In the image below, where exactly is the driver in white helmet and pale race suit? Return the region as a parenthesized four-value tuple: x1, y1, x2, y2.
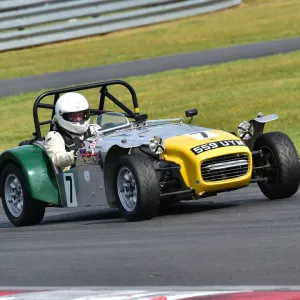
(45, 92, 100, 172)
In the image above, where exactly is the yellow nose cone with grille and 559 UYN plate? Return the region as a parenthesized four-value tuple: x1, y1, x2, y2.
(163, 130, 252, 196)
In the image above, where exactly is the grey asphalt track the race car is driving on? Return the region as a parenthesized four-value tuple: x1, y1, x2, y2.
(0, 184, 300, 286)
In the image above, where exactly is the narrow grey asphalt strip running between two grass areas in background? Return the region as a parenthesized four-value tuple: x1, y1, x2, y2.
(0, 37, 300, 97)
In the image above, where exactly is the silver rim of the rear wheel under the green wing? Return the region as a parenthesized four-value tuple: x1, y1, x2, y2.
(4, 174, 24, 218)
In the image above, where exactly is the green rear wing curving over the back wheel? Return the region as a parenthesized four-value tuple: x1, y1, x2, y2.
(0, 145, 61, 206)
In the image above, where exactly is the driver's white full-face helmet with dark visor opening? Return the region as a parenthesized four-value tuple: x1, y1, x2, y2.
(55, 92, 90, 134)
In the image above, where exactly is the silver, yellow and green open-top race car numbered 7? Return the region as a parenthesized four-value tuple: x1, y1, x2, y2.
(0, 80, 300, 226)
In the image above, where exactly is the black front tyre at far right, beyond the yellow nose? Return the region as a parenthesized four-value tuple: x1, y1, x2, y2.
(254, 132, 300, 199)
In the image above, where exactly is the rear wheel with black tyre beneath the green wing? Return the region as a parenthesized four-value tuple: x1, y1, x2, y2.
(0, 164, 45, 227)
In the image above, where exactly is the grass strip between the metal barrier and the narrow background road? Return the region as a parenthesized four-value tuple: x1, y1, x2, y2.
(0, 0, 300, 79)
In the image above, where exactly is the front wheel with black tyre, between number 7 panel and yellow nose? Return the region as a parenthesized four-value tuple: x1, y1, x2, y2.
(114, 154, 160, 221)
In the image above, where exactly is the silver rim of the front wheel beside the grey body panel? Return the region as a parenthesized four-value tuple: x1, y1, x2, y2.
(117, 167, 137, 211)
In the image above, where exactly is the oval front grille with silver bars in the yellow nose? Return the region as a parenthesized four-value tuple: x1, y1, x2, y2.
(201, 154, 249, 181)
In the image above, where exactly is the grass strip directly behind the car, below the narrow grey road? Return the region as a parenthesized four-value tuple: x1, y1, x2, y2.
(0, 51, 300, 153)
